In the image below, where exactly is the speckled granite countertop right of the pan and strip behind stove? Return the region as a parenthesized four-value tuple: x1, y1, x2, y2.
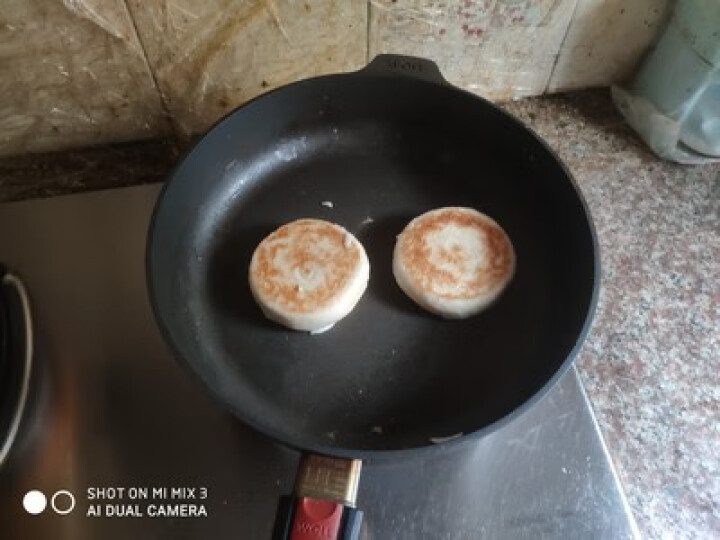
(0, 91, 720, 538)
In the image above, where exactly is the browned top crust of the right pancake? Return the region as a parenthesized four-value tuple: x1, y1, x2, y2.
(399, 208, 515, 300)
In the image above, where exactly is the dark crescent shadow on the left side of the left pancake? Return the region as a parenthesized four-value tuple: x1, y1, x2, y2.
(207, 224, 279, 330)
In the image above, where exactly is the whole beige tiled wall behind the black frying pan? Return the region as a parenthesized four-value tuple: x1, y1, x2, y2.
(0, 0, 670, 155)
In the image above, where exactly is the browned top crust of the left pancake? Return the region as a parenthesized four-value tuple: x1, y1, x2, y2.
(250, 219, 362, 313)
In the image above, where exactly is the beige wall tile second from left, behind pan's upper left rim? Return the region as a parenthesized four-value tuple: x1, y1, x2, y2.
(128, 0, 367, 134)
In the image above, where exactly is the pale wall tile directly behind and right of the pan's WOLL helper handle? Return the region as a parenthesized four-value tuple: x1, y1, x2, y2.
(369, 0, 577, 100)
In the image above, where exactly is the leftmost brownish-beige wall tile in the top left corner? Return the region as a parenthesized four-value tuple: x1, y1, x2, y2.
(0, 0, 170, 155)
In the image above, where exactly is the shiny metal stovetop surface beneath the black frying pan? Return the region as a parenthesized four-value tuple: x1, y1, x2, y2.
(0, 185, 637, 540)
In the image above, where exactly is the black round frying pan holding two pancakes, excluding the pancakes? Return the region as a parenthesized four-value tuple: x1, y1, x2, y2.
(147, 56, 599, 536)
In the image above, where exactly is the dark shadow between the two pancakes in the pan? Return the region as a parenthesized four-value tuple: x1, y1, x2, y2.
(357, 215, 435, 319)
